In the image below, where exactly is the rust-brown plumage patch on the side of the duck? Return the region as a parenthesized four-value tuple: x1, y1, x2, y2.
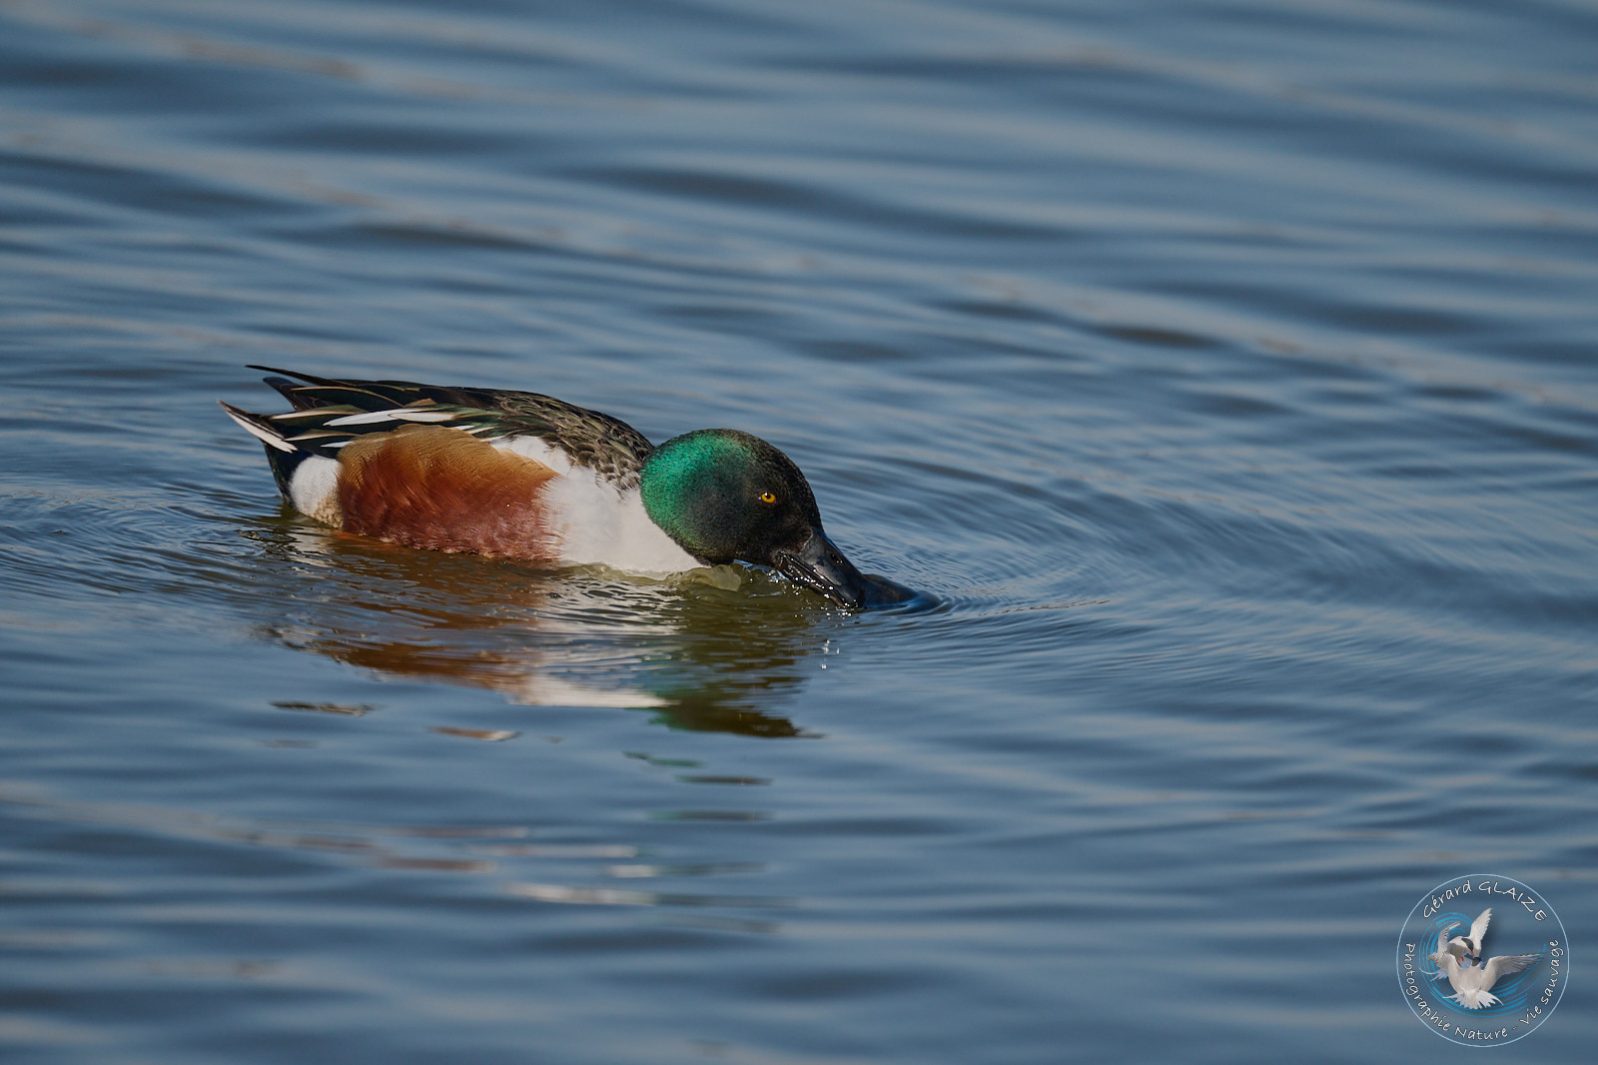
(339, 425, 559, 561)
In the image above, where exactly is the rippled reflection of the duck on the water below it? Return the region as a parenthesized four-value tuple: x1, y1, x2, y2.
(249, 518, 850, 737)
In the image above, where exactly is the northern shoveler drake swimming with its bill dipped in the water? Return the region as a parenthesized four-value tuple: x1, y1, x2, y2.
(222, 366, 912, 608)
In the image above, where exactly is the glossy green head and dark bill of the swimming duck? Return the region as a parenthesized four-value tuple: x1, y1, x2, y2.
(639, 429, 876, 608)
